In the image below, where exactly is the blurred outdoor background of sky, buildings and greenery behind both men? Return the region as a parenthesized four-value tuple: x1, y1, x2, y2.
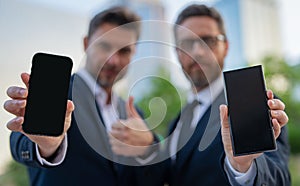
(0, 0, 300, 185)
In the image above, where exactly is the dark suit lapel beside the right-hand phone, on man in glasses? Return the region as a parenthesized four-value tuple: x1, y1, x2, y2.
(176, 91, 225, 170)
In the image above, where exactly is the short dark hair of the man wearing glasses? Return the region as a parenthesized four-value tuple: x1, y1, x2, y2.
(174, 4, 226, 39)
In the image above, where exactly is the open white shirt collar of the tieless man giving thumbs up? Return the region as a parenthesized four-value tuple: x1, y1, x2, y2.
(77, 68, 118, 107)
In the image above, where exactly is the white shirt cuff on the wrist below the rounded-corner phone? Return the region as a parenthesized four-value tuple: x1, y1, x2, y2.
(35, 134, 68, 166)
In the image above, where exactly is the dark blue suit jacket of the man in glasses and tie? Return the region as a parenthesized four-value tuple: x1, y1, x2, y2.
(137, 93, 290, 186)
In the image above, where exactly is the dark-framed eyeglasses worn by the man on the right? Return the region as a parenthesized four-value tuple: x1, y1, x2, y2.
(178, 34, 225, 52)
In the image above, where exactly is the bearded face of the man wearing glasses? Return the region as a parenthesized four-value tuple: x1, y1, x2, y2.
(175, 16, 228, 91)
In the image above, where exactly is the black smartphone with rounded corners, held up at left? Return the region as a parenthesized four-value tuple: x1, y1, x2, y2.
(23, 53, 73, 136)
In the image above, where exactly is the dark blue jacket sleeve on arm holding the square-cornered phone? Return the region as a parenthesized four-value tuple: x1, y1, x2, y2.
(255, 126, 291, 186)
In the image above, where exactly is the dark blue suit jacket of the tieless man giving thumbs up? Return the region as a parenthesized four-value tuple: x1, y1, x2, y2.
(10, 75, 134, 186)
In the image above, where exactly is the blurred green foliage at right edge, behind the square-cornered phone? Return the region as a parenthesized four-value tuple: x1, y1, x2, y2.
(262, 56, 300, 153)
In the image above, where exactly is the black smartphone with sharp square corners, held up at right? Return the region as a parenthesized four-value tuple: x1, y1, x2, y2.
(223, 65, 276, 156)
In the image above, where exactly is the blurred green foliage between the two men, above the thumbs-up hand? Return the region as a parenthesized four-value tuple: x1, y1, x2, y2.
(137, 67, 186, 137)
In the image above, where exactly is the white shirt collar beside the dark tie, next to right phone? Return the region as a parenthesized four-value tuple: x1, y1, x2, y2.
(187, 74, 224, 105)
